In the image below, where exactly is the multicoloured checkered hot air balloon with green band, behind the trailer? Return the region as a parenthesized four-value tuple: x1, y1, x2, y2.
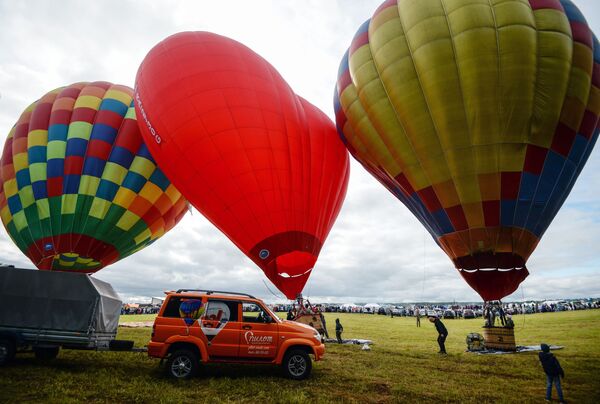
(0, 82, 187, 273)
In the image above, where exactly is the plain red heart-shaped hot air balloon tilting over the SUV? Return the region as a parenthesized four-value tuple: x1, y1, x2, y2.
(135, 32, 349, 299)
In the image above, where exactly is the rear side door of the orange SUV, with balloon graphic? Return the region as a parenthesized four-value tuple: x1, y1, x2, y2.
(198, 298, 240, 360)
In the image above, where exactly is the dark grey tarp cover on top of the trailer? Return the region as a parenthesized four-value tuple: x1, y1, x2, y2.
(0, 267, 122, 333)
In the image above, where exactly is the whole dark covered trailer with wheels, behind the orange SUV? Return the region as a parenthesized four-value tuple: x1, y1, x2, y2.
(0, 266, 133, 365)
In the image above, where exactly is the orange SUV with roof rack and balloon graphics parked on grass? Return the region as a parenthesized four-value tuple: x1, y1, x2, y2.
(148, 289, 325, 380)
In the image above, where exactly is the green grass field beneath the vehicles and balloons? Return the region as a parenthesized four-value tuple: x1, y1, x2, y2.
(0, 310, 600, 403)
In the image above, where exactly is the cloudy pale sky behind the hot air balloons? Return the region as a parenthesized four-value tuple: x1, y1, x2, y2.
(0, 0, 600, 302)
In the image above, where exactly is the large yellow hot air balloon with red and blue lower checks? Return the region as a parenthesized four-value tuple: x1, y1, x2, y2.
(334, 0, 600, 300)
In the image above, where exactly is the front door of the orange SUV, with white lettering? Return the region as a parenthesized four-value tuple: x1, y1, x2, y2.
(239, 303, 279, 360)
